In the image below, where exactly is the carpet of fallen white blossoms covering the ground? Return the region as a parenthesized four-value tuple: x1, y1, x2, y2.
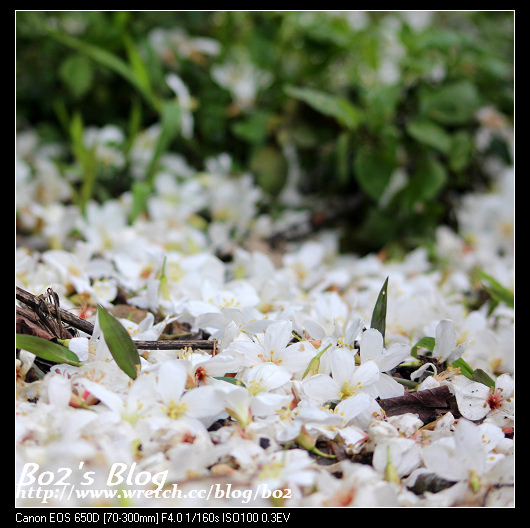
(16, 128, 514, 507)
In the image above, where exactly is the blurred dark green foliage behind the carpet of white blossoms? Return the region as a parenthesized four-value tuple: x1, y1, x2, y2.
(16, 11, 514, 252)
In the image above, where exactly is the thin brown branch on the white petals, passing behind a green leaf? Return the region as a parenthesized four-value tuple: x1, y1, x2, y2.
(16, 286, 217, 353)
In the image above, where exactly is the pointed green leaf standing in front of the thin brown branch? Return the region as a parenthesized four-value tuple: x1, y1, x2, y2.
(97, 304, 140, 379)
